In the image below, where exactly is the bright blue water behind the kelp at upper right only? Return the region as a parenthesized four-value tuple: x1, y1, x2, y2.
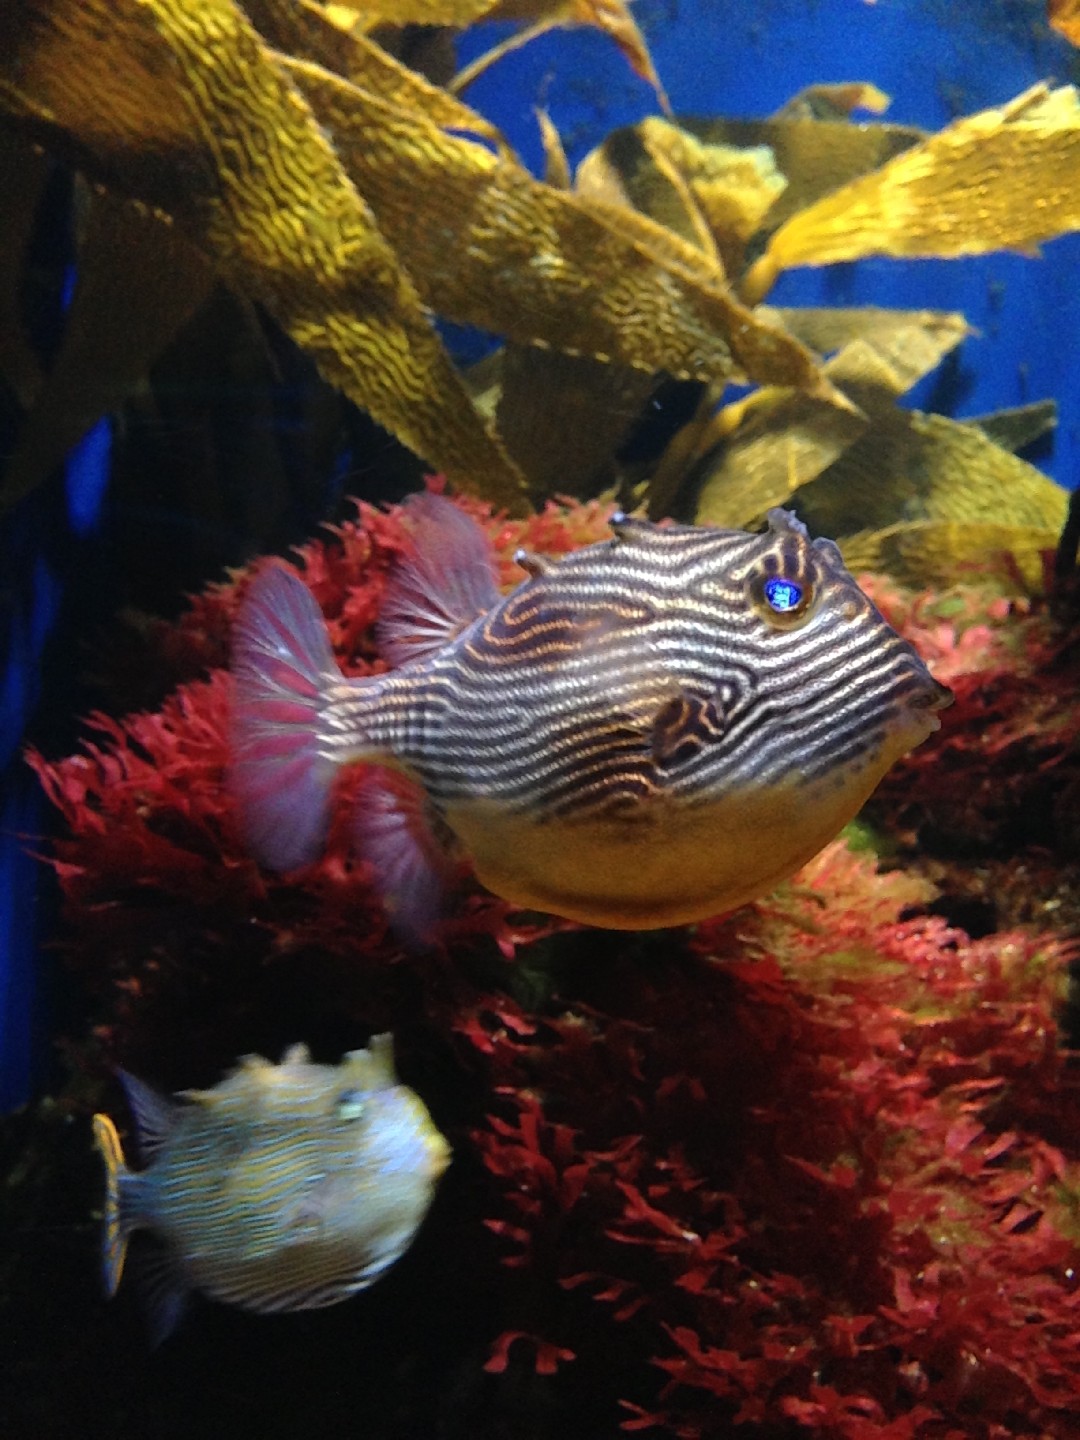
(459, 0, 1080, 463)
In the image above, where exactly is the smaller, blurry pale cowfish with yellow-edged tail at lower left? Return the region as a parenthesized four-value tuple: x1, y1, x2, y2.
(94, 1035, 449, 1339)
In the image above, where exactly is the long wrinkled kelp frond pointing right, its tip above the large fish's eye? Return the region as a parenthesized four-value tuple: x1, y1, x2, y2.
(284, 60, 829, 393)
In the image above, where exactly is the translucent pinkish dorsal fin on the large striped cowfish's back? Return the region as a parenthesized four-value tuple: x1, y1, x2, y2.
(376, 492, 500, 665)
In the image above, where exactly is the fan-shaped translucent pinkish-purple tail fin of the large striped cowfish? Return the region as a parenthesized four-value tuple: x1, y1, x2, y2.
(228, 562, 352, 871)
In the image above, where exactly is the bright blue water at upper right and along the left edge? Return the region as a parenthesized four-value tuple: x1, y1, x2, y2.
(0, 0, 1080, 1109)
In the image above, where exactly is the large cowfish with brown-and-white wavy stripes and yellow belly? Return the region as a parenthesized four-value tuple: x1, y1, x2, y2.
(230, 495, 952, 936)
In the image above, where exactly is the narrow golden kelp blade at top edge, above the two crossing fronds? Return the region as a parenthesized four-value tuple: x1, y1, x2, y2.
(243, 0, 505, 148)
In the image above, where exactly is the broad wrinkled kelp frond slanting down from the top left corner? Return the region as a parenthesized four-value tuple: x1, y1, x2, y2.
(0, 0, 523, 507)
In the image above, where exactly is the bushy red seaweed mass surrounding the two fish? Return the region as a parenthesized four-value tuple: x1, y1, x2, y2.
(23, 503, 1080, 1440)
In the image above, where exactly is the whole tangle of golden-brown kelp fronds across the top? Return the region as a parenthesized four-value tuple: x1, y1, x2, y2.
(0, 0, 1080, 555)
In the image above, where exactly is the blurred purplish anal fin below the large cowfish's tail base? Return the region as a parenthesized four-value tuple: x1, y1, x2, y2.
(354, 769, 454, 946)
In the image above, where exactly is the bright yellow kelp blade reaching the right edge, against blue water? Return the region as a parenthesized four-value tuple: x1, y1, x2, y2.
(744, 85, 1080, 300)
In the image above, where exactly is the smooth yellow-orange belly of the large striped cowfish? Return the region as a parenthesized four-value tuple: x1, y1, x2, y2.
(446, 756, 894, 930)
